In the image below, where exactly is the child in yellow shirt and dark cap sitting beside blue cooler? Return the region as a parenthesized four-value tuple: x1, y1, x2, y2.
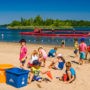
(28, 60, 46, 84)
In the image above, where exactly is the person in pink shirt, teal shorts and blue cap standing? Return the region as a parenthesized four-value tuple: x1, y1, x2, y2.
(79, 38, 87, 64)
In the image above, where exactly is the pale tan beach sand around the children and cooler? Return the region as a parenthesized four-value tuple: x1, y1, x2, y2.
(0, 42, 90, 90)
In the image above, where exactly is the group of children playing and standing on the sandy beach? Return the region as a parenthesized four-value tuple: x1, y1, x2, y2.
(19, 38, 90, 83)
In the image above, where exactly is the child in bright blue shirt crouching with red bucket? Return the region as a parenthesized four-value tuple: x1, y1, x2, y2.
(59, 62, 76, 83)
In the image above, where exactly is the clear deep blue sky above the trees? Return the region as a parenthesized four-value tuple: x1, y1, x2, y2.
(0, 0, 90, 24)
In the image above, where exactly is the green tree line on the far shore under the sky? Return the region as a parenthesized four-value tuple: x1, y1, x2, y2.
(9, 15, 90, 27)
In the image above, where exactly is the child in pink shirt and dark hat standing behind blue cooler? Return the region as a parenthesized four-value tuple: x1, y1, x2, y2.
(19, 39, 27, 68)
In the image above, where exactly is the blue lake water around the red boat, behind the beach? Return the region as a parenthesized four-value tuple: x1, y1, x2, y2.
(0, 28, 90, 46)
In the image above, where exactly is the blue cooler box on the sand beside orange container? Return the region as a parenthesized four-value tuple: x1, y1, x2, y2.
(6, 68, 29, 88)
